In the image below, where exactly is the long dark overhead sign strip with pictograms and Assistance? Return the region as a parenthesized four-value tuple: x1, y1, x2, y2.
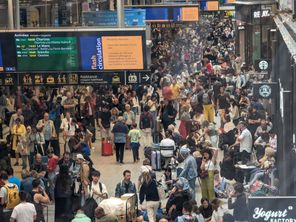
(0, 70, 151, 86)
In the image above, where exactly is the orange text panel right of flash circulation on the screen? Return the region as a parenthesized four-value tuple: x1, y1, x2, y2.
(102, 36, 144, 70)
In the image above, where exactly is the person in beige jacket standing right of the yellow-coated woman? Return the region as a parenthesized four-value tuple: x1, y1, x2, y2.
(36, 113, 57, 153)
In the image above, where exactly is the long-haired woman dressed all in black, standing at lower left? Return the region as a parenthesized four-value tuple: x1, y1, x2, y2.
(54, 165, 72, 220)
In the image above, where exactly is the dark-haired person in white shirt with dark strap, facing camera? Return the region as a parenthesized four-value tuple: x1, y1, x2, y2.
(88, 171, 108, 205)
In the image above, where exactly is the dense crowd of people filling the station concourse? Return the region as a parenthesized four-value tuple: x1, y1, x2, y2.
(0, 17, 278, 222)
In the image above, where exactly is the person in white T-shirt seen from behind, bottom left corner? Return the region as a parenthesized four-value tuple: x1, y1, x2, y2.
(10, 191, 37, 222)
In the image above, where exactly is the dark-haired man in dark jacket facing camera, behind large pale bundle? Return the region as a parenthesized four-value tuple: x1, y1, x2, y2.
(115, 170, 137, 198)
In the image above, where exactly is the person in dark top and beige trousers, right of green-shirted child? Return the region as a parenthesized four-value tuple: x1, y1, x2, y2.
(140, 106, 154, 147)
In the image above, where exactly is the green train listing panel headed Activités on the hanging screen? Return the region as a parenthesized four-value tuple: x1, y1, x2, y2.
(15, 34, 79, 71)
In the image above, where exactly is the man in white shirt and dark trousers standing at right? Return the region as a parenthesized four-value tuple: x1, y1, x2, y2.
(231, 121, 253, 163)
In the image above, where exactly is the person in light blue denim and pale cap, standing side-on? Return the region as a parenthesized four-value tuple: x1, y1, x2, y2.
(179, 146, 197, 200)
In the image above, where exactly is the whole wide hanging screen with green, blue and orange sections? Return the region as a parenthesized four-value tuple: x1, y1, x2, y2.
(0, 30, 146, 72)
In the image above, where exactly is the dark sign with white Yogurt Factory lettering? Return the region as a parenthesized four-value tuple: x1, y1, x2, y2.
(249, 196, 296, 222)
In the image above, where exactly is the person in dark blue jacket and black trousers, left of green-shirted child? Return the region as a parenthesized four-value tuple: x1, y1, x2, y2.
(112, 116, 128, 164)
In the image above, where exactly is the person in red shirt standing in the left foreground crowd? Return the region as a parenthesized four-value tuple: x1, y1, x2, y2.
(47, 149, 59, 200)
